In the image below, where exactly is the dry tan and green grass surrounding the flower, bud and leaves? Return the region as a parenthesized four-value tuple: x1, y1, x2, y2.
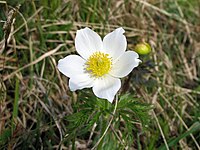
(0, 0, 200, 150)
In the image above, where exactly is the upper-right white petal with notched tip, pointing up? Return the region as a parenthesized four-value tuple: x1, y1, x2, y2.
(103, 27, 127, 60)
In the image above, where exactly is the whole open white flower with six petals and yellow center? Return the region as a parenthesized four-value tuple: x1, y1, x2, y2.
(58, 27, 141, 103)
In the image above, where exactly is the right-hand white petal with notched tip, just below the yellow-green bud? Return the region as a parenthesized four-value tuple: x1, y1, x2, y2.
(109, 51, 141, 78)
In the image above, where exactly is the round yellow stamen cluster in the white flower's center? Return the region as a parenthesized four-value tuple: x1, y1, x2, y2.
(86, 52, 112, 77)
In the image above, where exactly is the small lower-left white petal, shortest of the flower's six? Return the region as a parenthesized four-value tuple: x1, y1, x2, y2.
(69, 73, 94, 91)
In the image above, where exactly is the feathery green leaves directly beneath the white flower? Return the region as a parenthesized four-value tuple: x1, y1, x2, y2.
(63, 92, 152, 149)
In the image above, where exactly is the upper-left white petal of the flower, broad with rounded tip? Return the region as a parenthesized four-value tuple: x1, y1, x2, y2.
(75, 27, 103, 59)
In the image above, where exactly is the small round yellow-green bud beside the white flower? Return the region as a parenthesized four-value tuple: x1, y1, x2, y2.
(135, 42, 151, 55)
